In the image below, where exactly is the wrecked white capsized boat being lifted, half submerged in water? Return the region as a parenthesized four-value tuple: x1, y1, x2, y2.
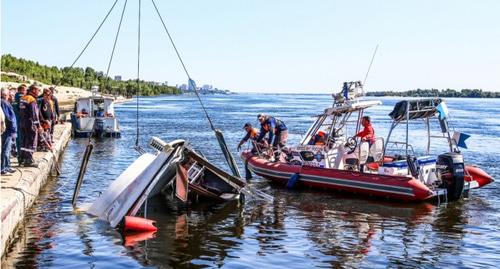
(87, 137, 245, 228)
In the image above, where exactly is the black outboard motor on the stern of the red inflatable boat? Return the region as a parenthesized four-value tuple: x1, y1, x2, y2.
(437, 152, 465, 201)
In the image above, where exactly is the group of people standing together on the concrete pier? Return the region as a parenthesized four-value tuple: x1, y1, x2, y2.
(1, 84, 60, 175)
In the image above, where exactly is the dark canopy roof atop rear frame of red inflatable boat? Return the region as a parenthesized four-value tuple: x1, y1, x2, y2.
(389, 98, 443, 121)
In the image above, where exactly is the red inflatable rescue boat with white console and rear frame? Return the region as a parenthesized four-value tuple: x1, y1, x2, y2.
(241, 81, 493, 201)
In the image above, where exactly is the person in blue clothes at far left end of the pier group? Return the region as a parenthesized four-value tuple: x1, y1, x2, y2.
(1, 89, 17, 175)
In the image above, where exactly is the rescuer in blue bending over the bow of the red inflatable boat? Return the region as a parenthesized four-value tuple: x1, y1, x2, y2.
(257, 114, 288, 162)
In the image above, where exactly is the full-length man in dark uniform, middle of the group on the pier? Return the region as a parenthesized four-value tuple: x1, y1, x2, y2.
(19, 85, 43, 167)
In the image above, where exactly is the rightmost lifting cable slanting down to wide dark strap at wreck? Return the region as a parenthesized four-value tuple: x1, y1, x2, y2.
(151, 0, 241, 178)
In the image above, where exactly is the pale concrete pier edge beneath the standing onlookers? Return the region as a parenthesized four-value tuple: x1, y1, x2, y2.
(0, 122, 71, 257)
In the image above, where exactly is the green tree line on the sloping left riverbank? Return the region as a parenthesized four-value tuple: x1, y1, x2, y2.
(1, 54, 182, 97)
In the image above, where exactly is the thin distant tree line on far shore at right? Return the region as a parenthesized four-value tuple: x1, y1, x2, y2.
(366, 89, 500, 98)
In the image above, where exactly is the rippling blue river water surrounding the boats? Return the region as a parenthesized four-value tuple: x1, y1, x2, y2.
(2, 94, 500, 268)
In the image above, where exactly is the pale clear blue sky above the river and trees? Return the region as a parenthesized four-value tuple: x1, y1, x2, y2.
(0, 0, 500, 93)
